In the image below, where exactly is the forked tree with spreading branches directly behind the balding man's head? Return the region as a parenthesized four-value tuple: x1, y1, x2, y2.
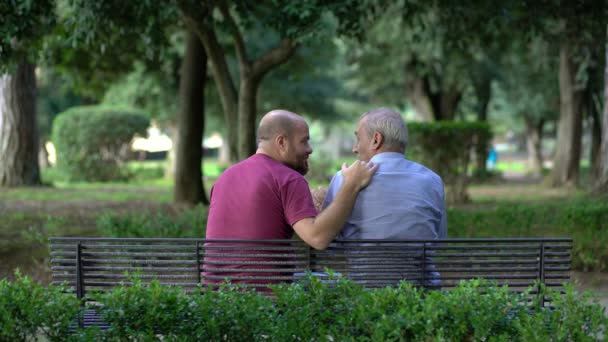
(178, 0, 376, 160)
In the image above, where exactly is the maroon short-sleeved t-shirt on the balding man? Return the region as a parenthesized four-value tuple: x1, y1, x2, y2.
(203, 154, 317, 290)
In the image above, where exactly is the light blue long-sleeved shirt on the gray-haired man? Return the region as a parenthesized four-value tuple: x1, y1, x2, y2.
(323, 152, 447, 239)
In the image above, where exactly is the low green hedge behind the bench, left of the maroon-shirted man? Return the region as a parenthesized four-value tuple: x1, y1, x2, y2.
(97, 205, 207, 238)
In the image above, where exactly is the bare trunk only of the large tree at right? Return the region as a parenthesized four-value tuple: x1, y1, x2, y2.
(549, 43, 583, 187)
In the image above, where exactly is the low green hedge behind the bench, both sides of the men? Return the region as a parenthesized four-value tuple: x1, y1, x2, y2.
(91, 198, 608, 271)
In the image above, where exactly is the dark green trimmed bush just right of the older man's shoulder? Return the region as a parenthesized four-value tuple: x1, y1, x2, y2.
(407, 121, 492, 203)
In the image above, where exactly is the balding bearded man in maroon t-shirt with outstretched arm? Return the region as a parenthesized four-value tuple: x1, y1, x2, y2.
(203, 110, 377, 285)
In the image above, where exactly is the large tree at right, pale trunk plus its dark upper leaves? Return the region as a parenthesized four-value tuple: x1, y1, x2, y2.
(533, 1, 607, 186)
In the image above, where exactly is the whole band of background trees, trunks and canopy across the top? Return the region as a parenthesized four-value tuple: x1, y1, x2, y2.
(0, 0, 608, 203)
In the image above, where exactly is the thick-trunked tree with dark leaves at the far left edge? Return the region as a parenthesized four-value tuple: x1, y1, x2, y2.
(0, 0, 55, 186)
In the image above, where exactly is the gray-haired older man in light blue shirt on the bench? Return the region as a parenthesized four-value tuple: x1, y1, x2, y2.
(323, 108, 447, 284)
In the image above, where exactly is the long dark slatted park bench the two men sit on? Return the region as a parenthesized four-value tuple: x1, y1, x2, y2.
(50, 237, 572, 326)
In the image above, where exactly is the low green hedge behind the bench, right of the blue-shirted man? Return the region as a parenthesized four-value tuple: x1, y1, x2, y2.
(448, 199, 608, 271)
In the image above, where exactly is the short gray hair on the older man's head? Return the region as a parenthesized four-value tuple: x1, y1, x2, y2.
(360, 108, 408, 153)
